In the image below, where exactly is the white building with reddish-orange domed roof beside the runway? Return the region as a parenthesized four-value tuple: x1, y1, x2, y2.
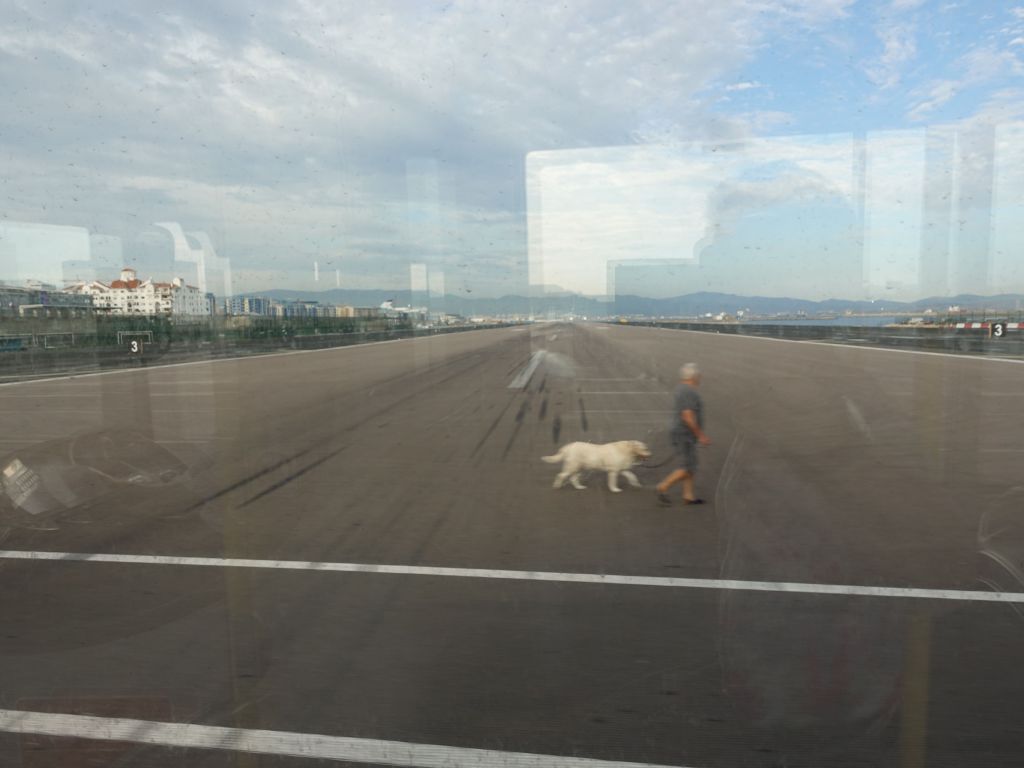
(67, 267, 210, 318)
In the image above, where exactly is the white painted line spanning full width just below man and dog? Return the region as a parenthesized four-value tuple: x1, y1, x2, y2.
(0, 550, 1024, 603)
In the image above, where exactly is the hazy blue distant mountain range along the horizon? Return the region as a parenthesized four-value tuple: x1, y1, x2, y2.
(245, 289, 1024, 317)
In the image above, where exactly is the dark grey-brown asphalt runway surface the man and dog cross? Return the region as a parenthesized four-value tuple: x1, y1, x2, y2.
(0, 324, 1024, 768)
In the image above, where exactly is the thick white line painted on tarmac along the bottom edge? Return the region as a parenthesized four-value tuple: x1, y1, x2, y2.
(0, 710, 696, 768)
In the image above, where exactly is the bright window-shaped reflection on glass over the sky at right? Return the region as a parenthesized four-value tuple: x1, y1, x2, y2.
(527, 123, 1024, 309)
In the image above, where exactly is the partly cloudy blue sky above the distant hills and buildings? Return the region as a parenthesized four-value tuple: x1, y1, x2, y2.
(0, 0, 1024, 299)
